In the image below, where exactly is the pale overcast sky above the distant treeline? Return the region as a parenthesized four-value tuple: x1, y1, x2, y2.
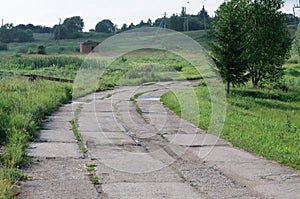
(0, 0, 298, 31)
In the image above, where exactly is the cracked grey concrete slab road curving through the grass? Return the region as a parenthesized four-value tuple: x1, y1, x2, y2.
(20, 82, 300, 199)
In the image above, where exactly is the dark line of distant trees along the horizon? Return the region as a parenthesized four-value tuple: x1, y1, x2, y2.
(0, 7, 300, 43)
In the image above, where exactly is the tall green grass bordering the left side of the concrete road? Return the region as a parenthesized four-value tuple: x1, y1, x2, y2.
(0, 77, 71, 198)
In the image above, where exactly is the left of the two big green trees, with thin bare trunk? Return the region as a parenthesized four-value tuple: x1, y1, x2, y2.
(211, 0, 248, 93)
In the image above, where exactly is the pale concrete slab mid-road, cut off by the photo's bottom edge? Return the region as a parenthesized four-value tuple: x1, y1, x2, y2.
(103, 183, 202, 199)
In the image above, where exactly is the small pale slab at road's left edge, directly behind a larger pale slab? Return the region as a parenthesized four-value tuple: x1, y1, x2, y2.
(39, 129, 77, 143)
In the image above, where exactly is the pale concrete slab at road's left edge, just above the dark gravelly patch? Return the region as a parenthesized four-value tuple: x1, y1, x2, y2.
(26, 142, 81, 158)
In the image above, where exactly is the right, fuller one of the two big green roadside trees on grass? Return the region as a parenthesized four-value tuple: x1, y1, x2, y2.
(245, 0, 291, 87)
